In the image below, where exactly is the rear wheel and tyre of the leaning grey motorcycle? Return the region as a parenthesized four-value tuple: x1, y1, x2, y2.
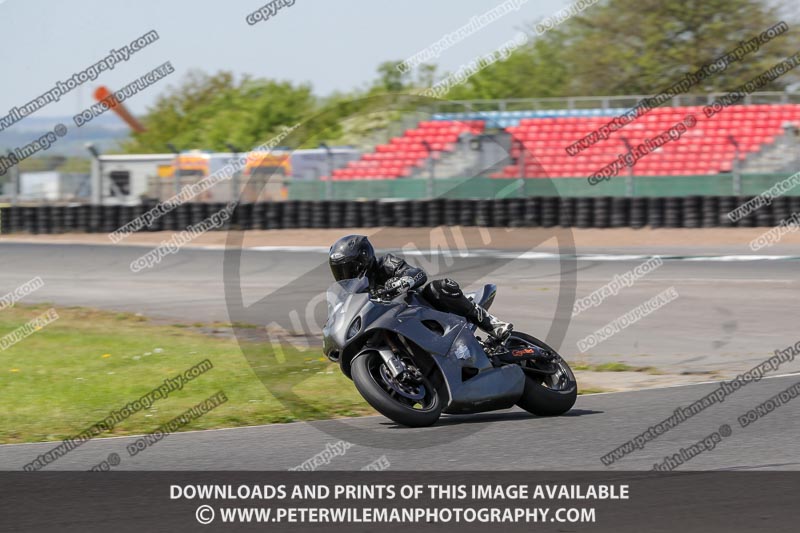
(506, 331, 578, 416)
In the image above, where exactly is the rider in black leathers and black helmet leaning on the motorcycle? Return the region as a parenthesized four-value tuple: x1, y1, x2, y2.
(328, 235, 514, 341)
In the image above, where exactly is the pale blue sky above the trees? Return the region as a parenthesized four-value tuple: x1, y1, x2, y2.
(0, 0, 569, 120)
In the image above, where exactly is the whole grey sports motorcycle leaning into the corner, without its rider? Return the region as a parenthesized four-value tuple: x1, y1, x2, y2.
(322, 276, 578, 427)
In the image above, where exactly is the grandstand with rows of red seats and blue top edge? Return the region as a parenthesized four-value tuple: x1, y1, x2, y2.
(322, 104, 800, 180)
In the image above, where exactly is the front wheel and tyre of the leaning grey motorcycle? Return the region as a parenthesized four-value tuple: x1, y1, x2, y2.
(350, 352, 444, 427)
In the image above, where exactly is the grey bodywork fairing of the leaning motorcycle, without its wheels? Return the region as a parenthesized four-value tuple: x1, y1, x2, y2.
(323, 278, 525, 414)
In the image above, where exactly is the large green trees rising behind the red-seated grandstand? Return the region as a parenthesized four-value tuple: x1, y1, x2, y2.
(410, 0, 800, 100)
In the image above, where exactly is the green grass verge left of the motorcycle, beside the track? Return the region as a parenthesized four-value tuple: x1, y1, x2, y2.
(0, 305, 373, 443)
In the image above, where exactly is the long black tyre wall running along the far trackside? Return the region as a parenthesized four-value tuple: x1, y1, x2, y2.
(0, 196, 800, 234)
